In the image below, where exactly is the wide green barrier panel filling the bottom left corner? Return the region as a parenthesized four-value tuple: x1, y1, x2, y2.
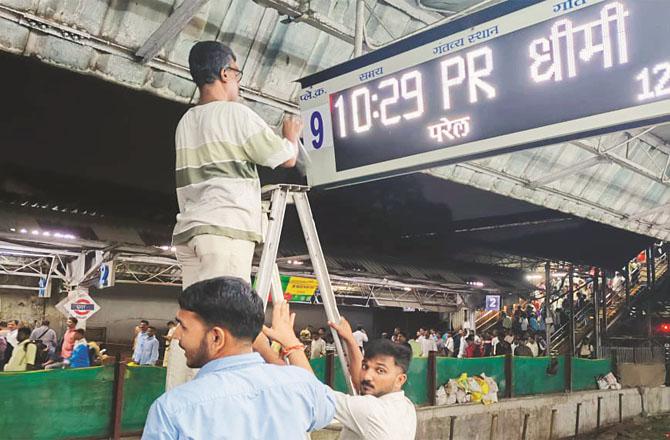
(0, 366, 114, 440)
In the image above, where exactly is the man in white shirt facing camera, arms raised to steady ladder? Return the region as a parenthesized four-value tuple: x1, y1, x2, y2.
(254, 303, 416, 440)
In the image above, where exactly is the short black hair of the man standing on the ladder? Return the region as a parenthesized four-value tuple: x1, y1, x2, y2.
(188, 41, 236, 87)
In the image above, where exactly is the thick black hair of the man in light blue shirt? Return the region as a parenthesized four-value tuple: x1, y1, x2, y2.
(179, 277, 265, 341)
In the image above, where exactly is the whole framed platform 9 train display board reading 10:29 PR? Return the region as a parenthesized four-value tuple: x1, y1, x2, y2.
(300, 0, 670, 186)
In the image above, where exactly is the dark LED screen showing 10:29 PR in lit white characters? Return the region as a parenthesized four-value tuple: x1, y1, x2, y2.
(330, 0, 670, 172)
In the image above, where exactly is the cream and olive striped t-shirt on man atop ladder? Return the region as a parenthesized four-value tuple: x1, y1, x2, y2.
(172, 101, 296, 245)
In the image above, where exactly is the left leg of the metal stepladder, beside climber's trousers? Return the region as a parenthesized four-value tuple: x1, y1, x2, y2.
(256, 188, 288, 309)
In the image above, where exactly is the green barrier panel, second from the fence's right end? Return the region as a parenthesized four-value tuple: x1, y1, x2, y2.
(512, 356, 565, 396)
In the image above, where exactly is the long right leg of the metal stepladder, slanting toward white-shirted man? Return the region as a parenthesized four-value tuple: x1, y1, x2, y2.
(293, 192, 355, 394)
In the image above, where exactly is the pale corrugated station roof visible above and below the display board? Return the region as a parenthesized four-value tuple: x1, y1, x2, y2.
(0, 0, 670, 248)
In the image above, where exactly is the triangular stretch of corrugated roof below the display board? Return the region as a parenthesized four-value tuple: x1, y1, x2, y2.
(427, 125, 670, 240)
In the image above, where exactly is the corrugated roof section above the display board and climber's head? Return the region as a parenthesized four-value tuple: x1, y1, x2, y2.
(0, 0, 491, 125)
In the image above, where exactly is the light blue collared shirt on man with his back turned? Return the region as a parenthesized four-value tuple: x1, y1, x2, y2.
(142, 353, 335, 440)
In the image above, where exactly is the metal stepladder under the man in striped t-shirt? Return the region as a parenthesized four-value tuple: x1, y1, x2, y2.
(256, 184, 355, 393)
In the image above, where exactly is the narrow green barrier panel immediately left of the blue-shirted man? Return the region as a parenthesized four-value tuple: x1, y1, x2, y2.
(121, 366, 167, 432)
